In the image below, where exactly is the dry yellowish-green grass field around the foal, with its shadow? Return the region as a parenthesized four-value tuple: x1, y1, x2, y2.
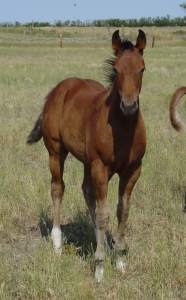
(0, 27, 186, 300)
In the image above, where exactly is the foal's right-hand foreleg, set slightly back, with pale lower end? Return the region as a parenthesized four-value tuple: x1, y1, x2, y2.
(114, 163, 141, 272)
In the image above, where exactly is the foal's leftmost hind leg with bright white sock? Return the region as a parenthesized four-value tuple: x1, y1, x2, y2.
(49, 151, 67, 253)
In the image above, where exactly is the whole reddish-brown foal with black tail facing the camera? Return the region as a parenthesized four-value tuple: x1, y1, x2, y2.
(27, 30, 146, 282)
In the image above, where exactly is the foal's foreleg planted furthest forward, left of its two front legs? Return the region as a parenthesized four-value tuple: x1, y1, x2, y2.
(91, 159, 109, 283)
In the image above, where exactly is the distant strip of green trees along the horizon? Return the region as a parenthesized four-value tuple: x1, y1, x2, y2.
(0, 16, 186, 27)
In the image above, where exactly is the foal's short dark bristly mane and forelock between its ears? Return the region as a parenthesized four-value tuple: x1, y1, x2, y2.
(104, 40, 134, 84)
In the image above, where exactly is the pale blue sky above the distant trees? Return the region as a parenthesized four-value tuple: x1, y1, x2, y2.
(0, 0, 186, 22)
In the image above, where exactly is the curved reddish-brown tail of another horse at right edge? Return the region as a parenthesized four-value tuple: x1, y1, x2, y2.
(169, 86, 186, 131)
